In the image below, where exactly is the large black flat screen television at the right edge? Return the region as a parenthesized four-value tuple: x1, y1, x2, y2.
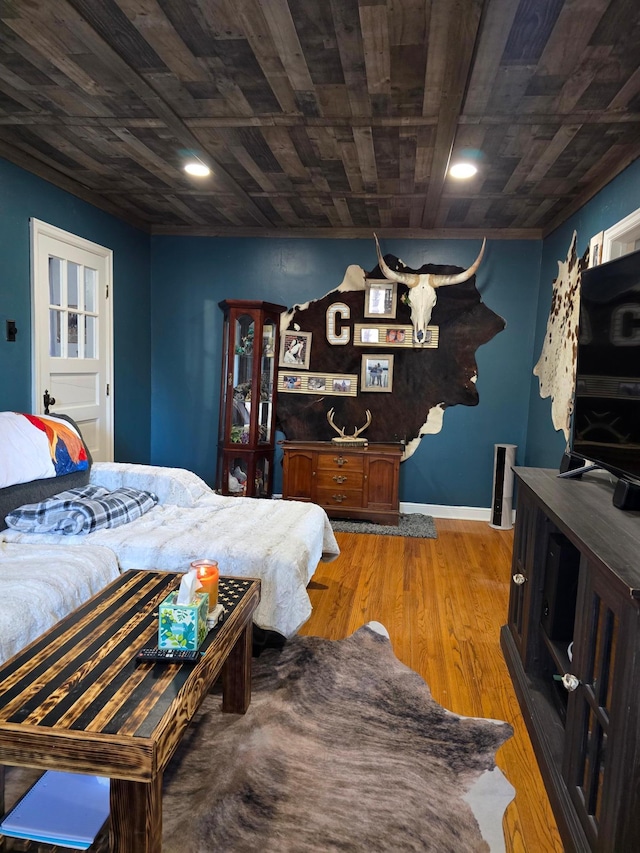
(571, 246, 640, 484)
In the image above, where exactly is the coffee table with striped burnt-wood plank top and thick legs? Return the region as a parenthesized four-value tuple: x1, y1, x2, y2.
(0, 571, 260, 853)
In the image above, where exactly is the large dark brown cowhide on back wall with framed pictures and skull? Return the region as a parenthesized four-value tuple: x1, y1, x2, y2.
(277, 236, 505, 460)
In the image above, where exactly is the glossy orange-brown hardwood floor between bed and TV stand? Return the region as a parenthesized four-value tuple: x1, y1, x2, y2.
(300, 519, 563, 853)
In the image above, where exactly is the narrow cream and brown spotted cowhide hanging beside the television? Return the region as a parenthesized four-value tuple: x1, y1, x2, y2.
(533, 231, 589, 442)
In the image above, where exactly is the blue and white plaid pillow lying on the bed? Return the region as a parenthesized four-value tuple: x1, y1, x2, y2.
(5, 485, 158, 535)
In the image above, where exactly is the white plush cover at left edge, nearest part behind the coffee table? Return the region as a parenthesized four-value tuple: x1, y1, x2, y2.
(0, 534, 120, 663)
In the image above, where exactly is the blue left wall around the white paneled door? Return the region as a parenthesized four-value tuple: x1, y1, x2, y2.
(0, 159, 151, 462)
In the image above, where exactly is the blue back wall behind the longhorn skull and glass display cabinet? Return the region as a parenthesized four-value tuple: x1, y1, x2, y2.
(151, 237, 542, 507)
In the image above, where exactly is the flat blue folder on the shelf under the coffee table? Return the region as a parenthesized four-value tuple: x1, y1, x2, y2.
(0, 770, 109, 850)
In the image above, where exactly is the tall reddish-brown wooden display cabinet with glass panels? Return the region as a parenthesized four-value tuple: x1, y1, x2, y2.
(216, 299, 286, 498)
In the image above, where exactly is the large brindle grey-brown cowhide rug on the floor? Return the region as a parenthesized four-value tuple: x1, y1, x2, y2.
(162, 623, 513, 853)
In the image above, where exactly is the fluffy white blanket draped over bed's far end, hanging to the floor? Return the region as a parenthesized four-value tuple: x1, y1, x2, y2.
(0, 463, 340, 637)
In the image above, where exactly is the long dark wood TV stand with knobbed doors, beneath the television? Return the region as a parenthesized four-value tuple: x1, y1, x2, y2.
(501, 468, 640, 853)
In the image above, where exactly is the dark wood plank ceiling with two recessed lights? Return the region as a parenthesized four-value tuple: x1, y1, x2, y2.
(0, 0, 640, 238)
